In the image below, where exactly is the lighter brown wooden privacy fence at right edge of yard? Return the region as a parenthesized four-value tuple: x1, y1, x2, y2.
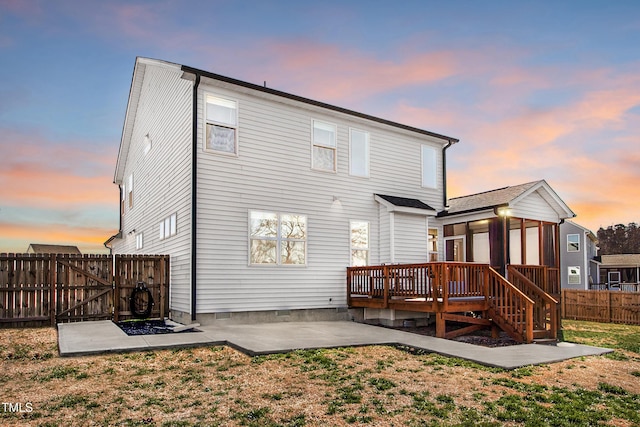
(562, 289, 640, 325)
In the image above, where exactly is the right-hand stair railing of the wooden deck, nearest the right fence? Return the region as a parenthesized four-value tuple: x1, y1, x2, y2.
(507, 266, 560, 339)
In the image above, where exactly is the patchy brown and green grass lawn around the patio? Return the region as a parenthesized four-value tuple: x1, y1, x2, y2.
(0, 321, 640, 427)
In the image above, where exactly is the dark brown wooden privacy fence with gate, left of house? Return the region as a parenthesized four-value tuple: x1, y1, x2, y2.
(0, 253, 169, 327)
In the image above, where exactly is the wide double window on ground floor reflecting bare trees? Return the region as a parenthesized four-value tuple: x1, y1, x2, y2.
(249, 211, 307, 265)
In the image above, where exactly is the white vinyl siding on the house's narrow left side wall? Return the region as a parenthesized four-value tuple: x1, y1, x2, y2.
(113, 63, 193, 313)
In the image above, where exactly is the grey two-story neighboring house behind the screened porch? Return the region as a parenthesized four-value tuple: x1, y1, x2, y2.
(560, 221, 600, 290)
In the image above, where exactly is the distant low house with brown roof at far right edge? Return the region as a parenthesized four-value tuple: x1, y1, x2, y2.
(600, 254, 640, 292)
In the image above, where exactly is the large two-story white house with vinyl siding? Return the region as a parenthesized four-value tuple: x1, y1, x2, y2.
(106, 58, 458, 323)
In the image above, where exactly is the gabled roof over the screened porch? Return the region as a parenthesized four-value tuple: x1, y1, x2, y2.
(439, 180, 576, 218)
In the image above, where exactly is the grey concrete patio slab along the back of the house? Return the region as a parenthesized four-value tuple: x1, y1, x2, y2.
(58, 321, 613, 369)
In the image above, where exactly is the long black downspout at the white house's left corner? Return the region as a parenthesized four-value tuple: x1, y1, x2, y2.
(191, 73, 200, 322)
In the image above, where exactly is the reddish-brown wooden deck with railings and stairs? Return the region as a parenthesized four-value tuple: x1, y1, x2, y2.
(347, 262, 558, 342)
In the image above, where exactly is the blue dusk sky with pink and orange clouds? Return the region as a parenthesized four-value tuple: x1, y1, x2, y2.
(0, 0, 640, 252)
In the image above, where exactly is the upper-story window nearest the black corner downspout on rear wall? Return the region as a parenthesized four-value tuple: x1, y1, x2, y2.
(205, 95, 238, 154)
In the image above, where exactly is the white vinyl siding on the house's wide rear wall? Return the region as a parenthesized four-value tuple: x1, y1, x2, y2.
(191, 72, 446, 313)
